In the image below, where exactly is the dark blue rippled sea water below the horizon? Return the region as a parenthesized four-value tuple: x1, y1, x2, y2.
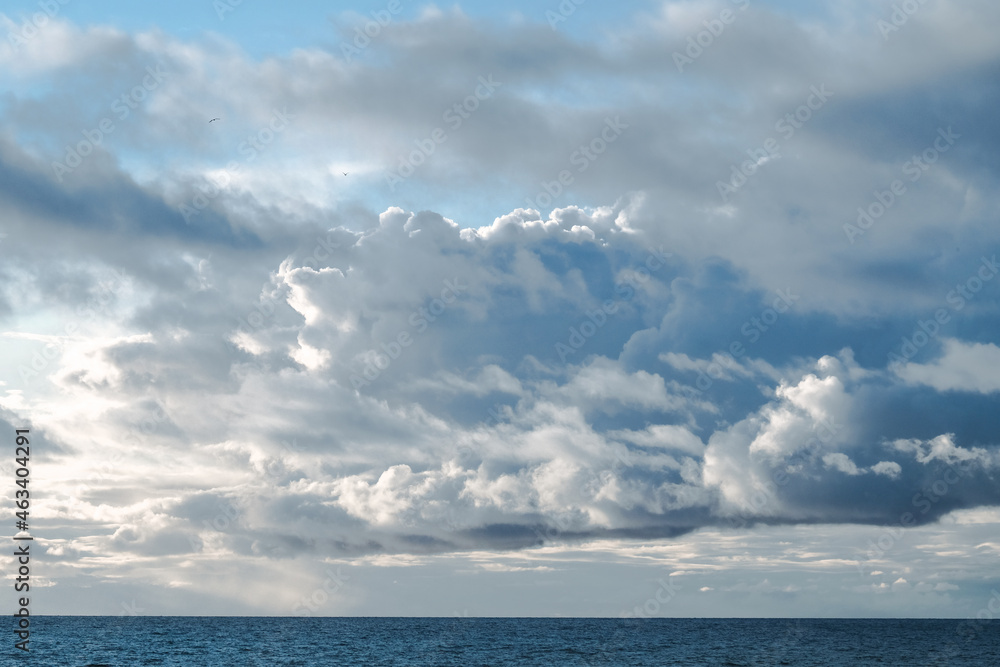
(13, 616, 1000, 667)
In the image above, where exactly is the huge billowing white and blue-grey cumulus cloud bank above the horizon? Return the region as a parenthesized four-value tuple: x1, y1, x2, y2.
(3, 196, 995, 568)
